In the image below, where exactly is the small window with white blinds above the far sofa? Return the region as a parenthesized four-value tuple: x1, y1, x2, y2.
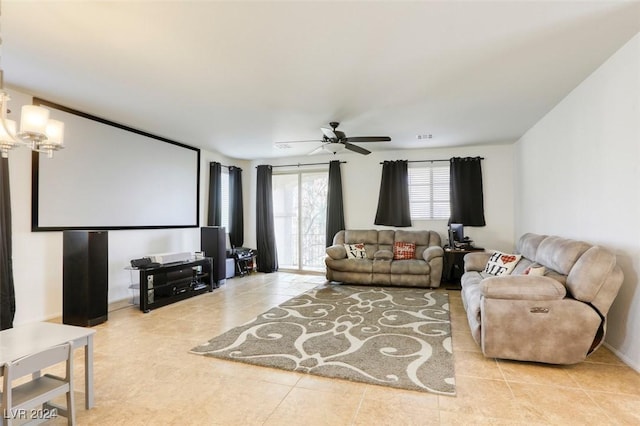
(408, 163, 451, 220)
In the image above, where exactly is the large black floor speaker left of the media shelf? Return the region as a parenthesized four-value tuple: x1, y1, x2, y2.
(62, 231, 109, 327)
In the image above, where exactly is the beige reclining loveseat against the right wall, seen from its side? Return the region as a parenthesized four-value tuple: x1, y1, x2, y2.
(461, 234, 623, 364)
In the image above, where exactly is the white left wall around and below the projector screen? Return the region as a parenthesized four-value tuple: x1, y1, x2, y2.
(9, 87, 248, 325)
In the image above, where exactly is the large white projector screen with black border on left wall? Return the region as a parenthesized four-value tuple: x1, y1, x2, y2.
(31, 98, 200, 231)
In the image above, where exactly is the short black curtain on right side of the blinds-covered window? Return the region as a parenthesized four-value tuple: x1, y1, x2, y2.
(449, 157, 486, 226)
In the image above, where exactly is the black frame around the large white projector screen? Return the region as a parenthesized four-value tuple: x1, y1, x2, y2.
(31, 97, 201, 232)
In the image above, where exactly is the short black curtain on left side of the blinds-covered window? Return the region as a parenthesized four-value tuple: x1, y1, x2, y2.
(374, 160, 411, 226)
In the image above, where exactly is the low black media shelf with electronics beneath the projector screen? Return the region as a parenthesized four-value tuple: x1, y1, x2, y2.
(135, 257, 215, 313)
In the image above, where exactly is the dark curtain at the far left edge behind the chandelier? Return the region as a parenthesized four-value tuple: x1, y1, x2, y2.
(0, 158, 16, 330)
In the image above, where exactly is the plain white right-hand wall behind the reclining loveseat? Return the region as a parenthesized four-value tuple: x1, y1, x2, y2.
(515, 34, 640, 371)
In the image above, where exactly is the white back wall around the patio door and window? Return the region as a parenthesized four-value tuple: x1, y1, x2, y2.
(245, 145, 514, 250)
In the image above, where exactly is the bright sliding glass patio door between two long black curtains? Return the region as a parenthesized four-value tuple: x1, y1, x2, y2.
(272, 171, 329, 271)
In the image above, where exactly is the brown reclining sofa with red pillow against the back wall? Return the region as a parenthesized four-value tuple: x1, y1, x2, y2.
(325, 230, 444, 287)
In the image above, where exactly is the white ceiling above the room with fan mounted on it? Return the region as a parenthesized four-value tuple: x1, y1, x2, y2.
(0, 0, 640, 159)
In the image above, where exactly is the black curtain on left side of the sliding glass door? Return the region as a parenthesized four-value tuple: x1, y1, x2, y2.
(256, 165, 278, 272)
